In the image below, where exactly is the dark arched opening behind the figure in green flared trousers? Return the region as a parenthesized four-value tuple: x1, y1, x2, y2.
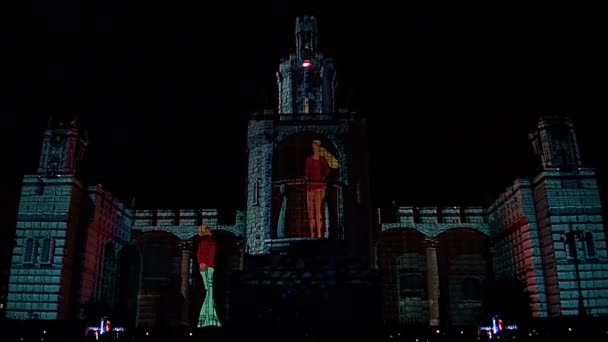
(190, 230, 244, 325)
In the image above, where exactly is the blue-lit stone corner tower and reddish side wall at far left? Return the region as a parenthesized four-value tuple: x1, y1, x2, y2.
(7, 118, 132, 320)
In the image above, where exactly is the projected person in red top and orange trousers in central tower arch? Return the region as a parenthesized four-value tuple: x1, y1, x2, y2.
(304, 140, 331, 238)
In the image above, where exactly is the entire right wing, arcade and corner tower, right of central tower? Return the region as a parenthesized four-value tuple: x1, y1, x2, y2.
(378, 115, 608, 325)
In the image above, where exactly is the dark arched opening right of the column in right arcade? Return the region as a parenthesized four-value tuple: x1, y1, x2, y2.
(437, 228, 490, 326)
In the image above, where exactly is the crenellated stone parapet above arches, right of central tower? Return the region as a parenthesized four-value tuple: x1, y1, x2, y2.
(380, 206, 490, 237)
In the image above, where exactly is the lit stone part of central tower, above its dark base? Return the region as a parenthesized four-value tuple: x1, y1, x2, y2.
(246, 16, 371, 255)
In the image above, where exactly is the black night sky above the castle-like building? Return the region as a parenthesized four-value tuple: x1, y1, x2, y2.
(0, 0, 608, 230)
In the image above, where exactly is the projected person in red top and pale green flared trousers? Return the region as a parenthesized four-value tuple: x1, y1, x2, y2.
(196, 226, 221, 327)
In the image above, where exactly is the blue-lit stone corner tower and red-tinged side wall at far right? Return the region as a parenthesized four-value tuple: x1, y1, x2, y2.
(488, 115, 608, 317)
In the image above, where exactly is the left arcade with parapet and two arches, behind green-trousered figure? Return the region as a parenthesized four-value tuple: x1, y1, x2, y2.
(132, 209, 245, 326)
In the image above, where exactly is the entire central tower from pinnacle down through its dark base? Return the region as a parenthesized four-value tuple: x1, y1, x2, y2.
(236, 16, 380, 332)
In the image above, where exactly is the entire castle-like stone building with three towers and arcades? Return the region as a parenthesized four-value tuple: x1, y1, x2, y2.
(6, 17, 608, 327)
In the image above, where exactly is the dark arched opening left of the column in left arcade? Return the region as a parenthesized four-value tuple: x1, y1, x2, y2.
(134, 231, 184, 327)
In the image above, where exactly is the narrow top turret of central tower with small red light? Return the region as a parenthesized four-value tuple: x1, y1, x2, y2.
(277, 17, 336, 113)
